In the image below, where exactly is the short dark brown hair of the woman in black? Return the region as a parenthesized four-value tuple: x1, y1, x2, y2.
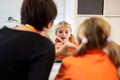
(21, 0, 57, 31)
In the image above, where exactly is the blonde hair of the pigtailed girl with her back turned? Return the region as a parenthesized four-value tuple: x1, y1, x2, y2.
(77, 17, 111, 55)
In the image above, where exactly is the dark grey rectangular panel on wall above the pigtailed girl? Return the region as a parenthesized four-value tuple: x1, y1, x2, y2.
(77, 0, 104, 15)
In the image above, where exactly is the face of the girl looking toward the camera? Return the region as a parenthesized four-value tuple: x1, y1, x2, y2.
(56, 26, 71, 42)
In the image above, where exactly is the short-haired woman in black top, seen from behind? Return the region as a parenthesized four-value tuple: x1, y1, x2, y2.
(0, 0, 57, 80)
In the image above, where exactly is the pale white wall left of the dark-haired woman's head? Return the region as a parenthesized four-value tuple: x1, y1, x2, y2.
(0, 0, 22, 28)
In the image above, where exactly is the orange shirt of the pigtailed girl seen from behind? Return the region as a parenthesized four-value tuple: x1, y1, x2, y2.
(55, 50, 119, 80)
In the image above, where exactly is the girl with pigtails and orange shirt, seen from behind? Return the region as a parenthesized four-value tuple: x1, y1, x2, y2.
(54, 17, 119, 80)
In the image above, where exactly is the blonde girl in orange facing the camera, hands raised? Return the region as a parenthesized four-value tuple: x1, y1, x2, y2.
(53, 21, 78, 61)
